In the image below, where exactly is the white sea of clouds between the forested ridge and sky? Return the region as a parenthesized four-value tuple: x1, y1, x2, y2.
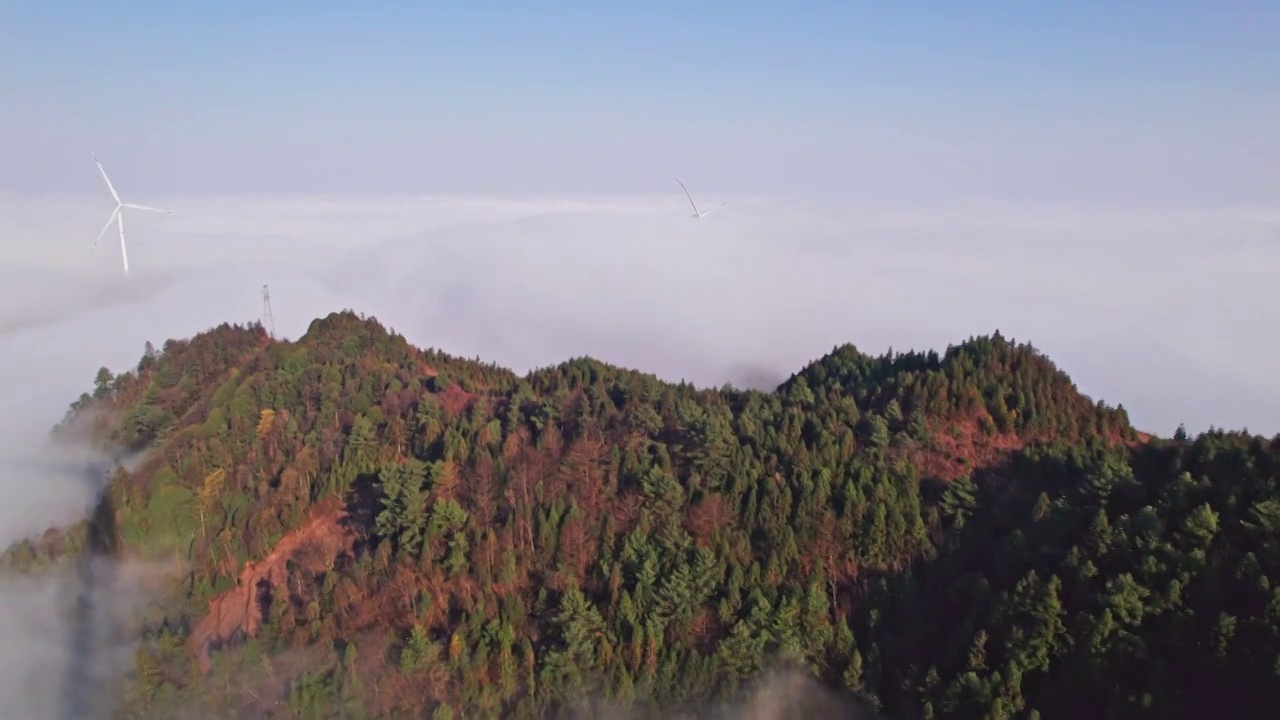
(0, 188, 1280, 542)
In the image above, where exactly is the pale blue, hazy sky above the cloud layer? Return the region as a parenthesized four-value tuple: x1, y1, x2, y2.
(0, 0, 1280, 205)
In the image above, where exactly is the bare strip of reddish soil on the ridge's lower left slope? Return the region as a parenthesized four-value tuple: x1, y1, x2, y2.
(188, 505, 355, 673)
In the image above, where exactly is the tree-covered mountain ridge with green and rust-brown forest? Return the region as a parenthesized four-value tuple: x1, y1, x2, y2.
(5, 313, 1280, 719)
